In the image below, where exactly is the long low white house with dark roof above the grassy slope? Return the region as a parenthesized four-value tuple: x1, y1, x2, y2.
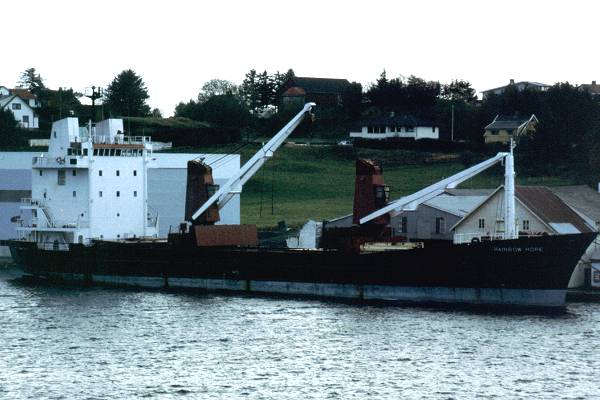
(350, 113, 440, 140)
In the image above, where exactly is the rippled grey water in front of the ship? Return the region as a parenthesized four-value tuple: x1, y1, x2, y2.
(0, 269, 600, 399)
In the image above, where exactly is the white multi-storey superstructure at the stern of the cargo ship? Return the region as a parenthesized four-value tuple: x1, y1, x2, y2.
(17, 118, 159, 248)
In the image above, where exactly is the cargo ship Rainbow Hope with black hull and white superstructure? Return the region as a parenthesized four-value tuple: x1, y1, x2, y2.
(4, 103, 596, 309)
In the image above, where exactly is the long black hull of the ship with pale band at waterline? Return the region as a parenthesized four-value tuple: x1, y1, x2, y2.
(7, 233, 595, 308)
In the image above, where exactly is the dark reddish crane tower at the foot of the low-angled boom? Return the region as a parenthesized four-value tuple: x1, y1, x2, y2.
(352, 159, 390, 225)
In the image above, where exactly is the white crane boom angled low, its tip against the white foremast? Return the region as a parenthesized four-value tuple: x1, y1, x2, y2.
(360, 151, 514, 225)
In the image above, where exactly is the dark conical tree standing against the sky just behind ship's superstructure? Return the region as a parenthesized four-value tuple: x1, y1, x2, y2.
(104, 69, 150, 117)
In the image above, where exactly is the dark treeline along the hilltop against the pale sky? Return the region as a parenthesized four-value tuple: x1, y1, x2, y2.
(0, 68, 600, 182)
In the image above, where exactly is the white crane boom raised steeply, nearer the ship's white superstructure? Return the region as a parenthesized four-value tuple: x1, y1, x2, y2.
(192, 103, 316, 220)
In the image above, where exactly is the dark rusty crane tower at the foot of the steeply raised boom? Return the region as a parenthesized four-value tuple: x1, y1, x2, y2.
(185, 160, 220, 225)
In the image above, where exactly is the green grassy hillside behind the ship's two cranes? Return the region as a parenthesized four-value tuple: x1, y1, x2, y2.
(161, 144, 571, 227)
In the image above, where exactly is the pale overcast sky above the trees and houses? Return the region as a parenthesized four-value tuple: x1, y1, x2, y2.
(0, 0, 600, 116)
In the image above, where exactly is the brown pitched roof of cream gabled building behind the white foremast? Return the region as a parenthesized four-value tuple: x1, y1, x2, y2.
(451, 186, 593, 233)
